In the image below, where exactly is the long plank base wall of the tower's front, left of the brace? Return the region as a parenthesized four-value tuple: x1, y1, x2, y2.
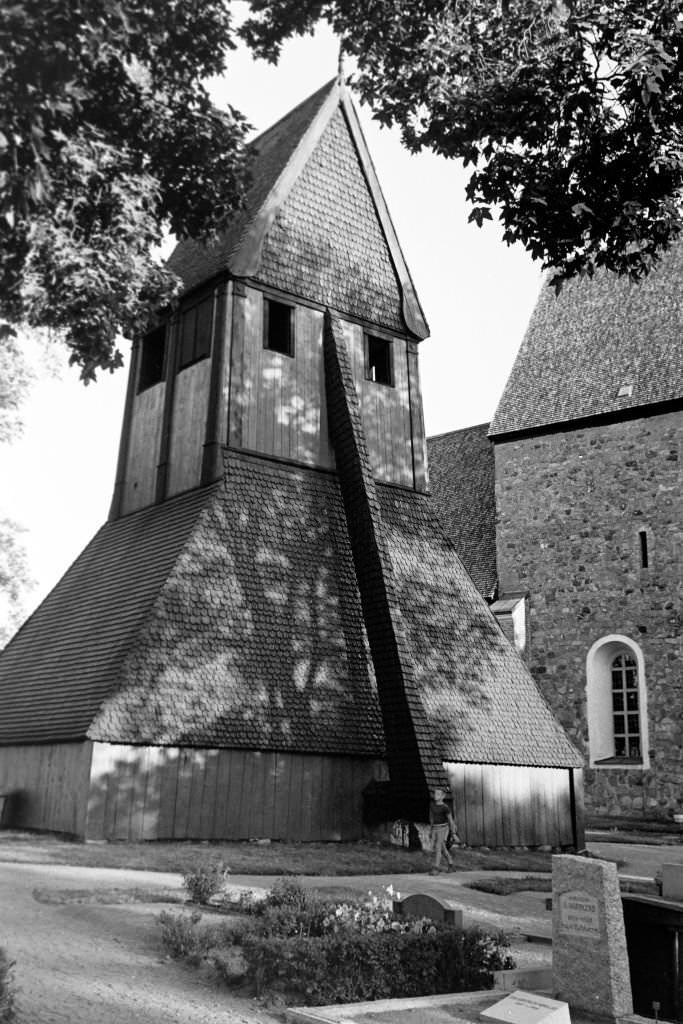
(87, 743, 387, 842)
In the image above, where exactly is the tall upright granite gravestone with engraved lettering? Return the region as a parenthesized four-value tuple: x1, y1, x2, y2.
(553, 854, 633, 1020)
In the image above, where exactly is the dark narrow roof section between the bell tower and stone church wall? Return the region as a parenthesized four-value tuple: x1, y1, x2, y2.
(427, 423, 497, 600)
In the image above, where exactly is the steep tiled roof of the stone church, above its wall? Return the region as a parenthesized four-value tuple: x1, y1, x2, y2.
(490, 244, 683, 435)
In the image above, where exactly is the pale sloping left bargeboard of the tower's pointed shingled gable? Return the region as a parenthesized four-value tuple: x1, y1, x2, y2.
(231, 78, 343, 278)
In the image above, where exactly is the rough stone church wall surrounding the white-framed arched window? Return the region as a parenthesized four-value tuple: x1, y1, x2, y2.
(496, 412, 683, 818)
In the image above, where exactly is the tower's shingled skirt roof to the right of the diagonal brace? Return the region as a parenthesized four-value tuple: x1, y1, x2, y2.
(378, 485, 583, 768)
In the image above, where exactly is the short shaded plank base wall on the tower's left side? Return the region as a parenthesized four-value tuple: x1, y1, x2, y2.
(0, 740, 92, 837)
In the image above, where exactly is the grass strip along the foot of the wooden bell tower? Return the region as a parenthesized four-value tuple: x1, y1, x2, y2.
(0, 830, 550, 876)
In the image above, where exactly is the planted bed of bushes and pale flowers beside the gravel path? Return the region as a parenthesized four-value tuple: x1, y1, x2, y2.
(161, 881, 514, 1006)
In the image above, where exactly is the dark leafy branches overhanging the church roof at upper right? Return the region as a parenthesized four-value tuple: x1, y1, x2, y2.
(243, 0, 683, 287)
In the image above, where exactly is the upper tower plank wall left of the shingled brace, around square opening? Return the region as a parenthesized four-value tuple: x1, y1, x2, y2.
(229, 288, 334, 469)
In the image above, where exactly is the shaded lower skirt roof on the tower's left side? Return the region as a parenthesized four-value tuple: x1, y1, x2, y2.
(0, 487, 214, 743)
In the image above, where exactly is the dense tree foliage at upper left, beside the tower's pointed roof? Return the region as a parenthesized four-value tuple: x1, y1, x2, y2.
(0, 0, 248, 380)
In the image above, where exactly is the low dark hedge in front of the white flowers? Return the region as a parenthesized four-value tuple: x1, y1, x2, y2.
(243, 928, 512, 1006)
